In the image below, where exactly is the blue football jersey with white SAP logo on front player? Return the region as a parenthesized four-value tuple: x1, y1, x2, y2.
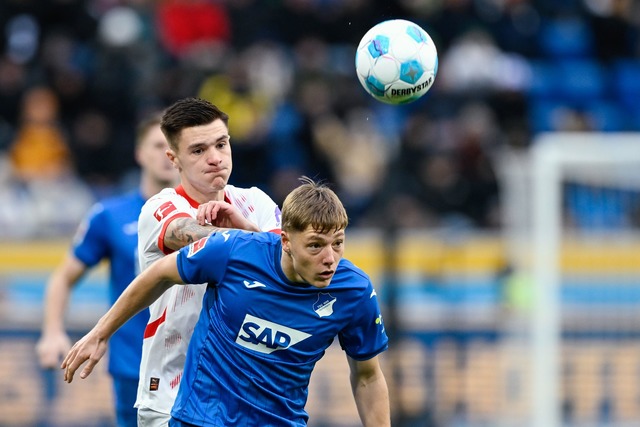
(172, 230, 388, 427)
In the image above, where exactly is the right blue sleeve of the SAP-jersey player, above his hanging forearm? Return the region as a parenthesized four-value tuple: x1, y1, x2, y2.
(338, 282, 389, 360)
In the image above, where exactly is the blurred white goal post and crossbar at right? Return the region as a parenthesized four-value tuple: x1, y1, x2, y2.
(501, 132, 640, 427)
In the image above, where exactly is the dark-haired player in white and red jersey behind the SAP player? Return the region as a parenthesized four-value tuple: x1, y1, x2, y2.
(136, 98, 280, 427)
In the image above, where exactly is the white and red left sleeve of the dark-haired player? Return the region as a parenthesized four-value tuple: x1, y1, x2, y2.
(138, 189, 194, 255)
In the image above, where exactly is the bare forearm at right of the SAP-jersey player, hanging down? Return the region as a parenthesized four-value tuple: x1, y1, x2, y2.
(347, 356, 391, 427)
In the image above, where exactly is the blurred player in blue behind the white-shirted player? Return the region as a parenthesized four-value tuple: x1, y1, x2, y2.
(37, 113, 178, 427)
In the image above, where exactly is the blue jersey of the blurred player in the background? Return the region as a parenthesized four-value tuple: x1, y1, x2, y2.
(73, 191, 149, 379)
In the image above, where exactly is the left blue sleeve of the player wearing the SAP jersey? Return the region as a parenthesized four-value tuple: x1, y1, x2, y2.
(177, 230, 237, 285)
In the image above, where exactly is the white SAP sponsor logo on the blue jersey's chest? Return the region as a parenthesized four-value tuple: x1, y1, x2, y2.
(236, 314, 311, 354)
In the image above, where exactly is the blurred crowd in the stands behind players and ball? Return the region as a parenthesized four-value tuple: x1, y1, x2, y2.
(0, 0, 640, 238)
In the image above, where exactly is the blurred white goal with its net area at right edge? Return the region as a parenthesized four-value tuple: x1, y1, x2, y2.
(500, 133, 640, 427)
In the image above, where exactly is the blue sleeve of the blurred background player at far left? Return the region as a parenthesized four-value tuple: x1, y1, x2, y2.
(72, 203, 109, 267)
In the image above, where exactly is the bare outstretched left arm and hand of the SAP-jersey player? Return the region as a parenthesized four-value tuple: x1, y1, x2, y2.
(61, 252, 182, 383)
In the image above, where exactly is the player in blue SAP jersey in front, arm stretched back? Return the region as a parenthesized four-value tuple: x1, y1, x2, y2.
(62, 178, 391, 427)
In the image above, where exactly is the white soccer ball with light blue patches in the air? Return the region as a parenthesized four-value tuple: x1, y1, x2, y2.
(356, 19, 438, 105)
